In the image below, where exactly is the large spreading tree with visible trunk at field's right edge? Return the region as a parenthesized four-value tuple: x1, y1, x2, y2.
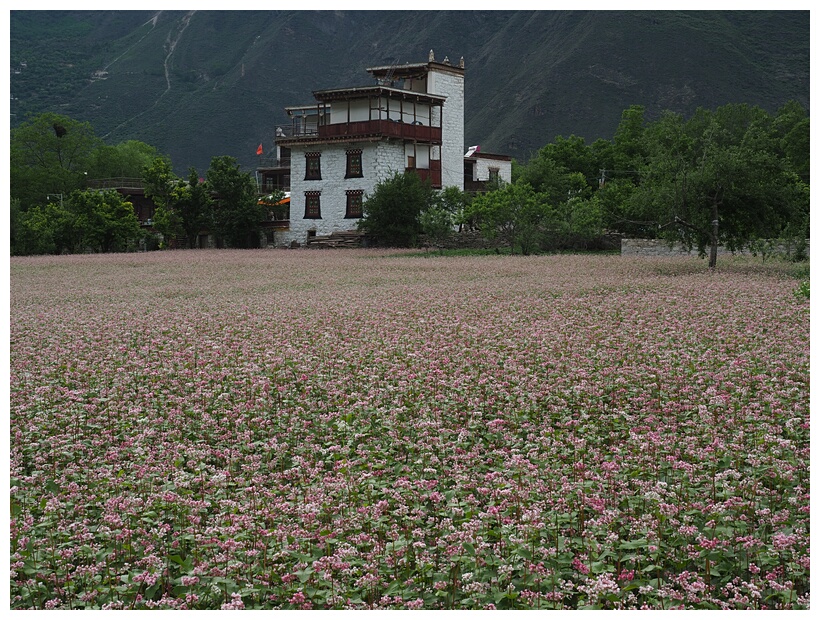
(630, 104, 808, 268)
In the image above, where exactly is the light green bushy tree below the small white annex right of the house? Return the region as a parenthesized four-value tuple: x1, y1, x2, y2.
(467, 182, 555, 255)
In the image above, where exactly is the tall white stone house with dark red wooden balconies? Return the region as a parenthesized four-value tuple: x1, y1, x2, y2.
(266, 51, 465, 245)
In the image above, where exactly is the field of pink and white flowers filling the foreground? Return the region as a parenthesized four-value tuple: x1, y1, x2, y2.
(10, 250, 810, 609)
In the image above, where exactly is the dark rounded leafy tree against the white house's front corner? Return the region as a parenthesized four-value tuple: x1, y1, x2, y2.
(359, 171, 434, 247)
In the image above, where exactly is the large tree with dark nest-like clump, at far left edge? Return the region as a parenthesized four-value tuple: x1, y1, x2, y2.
(9, 112, 102, 211)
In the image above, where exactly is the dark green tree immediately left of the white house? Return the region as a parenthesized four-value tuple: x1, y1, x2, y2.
(205, 156, 265, 248)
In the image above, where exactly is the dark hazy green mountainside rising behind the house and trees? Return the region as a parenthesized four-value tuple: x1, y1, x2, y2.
(10, 11, 810, 173)
